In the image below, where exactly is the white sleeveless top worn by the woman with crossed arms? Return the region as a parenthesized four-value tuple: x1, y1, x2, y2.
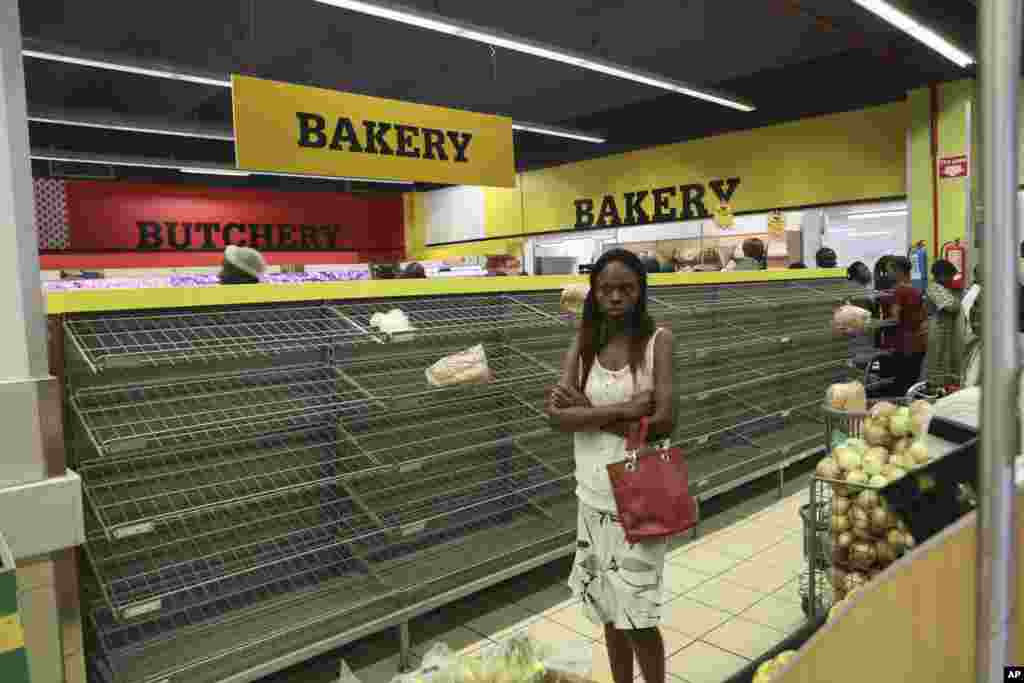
(573, 328, 662, 512)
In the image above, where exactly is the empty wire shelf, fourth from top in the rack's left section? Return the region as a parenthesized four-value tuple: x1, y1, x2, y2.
(86, 488, 380, 620)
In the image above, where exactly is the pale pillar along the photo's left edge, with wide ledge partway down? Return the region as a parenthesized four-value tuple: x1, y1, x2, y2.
(0, 0, 85, 682)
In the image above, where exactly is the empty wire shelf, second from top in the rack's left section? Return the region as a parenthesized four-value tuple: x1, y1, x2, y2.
(72, 366, 367, 456)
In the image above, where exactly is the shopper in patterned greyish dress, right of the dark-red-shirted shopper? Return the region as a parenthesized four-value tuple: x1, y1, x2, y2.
(926, 259, 968, 394)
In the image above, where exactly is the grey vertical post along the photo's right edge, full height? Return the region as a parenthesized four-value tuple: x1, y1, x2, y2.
(976, 0, 1024, 683)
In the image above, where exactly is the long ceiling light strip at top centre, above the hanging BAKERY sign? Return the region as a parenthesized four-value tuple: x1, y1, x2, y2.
(316, 0, 755, 112)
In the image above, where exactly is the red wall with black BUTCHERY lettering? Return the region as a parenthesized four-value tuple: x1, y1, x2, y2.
(41, 180, 404, 269)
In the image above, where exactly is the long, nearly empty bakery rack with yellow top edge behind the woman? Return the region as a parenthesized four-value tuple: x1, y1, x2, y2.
(50, 273, 853, 683)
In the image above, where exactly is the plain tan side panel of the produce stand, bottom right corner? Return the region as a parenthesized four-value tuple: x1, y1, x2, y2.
(771, 490, 1024, 683)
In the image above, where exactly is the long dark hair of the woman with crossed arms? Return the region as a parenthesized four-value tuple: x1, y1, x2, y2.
(580, 249, 654, 391)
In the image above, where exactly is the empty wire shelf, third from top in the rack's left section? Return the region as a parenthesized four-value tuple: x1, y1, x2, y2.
(81, 425, 384, 538)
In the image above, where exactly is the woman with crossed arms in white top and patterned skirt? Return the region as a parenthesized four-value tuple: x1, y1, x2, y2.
(547, 249, 675, 683)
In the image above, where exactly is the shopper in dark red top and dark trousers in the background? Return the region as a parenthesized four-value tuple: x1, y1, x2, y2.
(880, 256, 928, 396)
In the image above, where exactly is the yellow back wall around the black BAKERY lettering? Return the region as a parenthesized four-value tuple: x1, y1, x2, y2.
(407, 97, 910, 254)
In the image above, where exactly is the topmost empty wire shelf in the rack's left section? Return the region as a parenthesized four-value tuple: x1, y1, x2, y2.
(65, 305, 367, 373)
